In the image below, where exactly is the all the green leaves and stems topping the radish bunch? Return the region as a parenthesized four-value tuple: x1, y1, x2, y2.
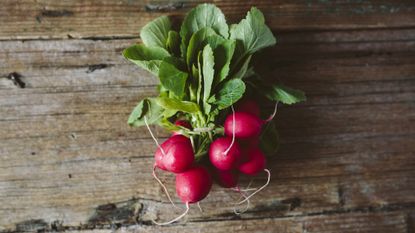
(123, 4, 305, 158)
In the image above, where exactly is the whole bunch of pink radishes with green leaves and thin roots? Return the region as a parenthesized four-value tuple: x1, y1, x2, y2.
(123, 4, 305, 224)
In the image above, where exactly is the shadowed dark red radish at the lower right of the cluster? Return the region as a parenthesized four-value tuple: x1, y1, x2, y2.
(238, 148, 266, 175)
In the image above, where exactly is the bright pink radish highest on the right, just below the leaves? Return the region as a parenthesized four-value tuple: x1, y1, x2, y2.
(224, 112, 263, 139)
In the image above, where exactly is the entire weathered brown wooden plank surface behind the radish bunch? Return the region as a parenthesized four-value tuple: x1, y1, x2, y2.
(0, 0, 415, 233)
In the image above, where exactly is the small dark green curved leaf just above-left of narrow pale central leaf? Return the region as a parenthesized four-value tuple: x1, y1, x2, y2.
(186, 27, 216, 67)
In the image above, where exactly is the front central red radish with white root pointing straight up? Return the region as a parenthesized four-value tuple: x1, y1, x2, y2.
(209, 137, 241, 171)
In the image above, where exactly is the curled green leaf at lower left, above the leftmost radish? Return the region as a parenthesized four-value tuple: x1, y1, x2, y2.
(128, 98, 163, 127)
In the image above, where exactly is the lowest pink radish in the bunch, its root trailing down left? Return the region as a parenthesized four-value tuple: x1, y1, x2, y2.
(176, 166, 212, 203)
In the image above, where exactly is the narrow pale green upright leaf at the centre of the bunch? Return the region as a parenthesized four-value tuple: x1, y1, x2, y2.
(202, 45, 215, 114)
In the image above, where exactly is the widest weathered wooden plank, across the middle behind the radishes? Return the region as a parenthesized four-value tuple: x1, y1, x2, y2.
(0, 29, 415, 232)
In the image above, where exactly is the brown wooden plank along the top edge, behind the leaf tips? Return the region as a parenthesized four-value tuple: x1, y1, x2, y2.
(0, 0, 415, 40)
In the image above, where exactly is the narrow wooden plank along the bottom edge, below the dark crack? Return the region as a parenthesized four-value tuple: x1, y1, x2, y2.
(17, 212, 408, 233)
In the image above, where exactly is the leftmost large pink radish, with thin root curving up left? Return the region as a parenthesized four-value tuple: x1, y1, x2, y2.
(155, 135, 195, 173)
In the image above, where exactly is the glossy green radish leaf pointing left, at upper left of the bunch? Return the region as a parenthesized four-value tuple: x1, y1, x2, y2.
(123, 44, 170, 75)
